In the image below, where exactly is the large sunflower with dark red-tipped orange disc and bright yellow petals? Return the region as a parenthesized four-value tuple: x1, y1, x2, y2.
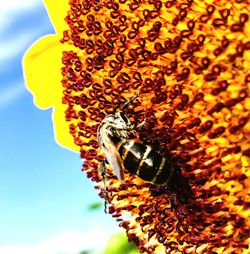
(24, 0, 250, 253)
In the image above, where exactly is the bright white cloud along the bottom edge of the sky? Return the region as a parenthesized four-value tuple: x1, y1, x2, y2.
(0, 228, 110, 254)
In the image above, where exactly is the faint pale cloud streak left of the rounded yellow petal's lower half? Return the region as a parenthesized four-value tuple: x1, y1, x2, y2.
(0, 82, 26, 108)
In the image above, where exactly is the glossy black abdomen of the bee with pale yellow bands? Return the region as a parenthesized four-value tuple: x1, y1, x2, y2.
(117, 140, 174, 184)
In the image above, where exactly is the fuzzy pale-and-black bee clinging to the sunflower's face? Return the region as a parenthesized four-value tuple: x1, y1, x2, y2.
(97, 95, 175, 210)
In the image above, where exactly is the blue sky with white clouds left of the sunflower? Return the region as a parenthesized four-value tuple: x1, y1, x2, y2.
(0, 0, 118, 254)
